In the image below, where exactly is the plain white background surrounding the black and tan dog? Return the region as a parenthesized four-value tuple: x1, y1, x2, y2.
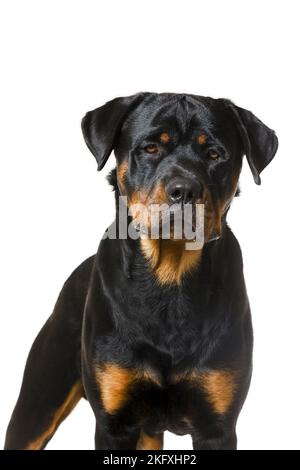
(0, 0, 300, 449)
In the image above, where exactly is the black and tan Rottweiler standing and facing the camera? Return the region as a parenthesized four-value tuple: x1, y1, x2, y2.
(5, 93, 278, 450)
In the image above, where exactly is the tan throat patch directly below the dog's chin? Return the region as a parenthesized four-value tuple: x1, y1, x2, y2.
(141, 238, 202, 285)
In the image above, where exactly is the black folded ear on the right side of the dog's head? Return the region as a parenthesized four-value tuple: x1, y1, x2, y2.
(229, 103, 278, 184)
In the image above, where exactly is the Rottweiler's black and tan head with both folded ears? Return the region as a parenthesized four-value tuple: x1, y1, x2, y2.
(82, 93, 278, 241)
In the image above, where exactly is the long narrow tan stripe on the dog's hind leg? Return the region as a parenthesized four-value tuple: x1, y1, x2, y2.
(25, 381, 84, 450)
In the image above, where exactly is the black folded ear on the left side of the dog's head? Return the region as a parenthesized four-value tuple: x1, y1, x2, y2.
(81, 93, 145, 170)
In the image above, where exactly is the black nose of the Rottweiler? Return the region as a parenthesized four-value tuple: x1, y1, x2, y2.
(165, 177, 202, 204)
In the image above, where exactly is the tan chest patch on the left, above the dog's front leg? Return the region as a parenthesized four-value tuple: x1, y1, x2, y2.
(95, 363, 160, 414)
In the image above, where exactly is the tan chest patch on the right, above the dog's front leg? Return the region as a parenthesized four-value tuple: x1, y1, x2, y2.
(172, 370, 237, 415)
